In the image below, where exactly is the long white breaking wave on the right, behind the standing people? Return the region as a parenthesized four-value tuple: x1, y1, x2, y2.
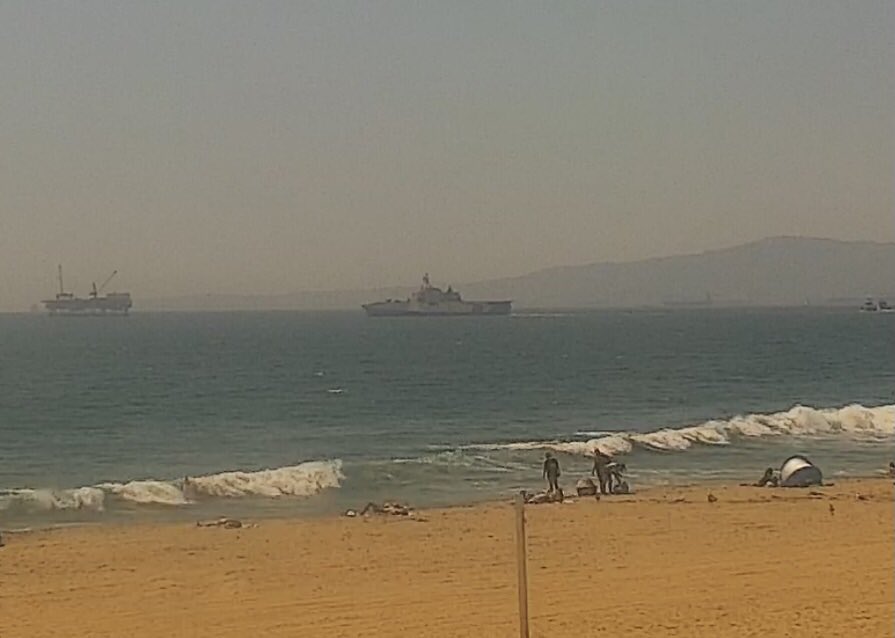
(467, 404, 895, 456)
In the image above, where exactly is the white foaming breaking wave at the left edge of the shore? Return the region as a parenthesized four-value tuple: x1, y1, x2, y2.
(0, 459, 345, 512)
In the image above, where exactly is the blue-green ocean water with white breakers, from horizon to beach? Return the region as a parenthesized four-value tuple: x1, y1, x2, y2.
(0, 308, 895, 529)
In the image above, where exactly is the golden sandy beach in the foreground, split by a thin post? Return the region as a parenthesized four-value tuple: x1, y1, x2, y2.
(0, 480, 895, 638)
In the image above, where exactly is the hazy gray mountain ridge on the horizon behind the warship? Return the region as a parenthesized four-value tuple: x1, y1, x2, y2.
(140, 237, 895, 310)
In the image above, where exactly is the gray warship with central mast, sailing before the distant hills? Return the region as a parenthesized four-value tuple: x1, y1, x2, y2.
(362, 273, 513, 317)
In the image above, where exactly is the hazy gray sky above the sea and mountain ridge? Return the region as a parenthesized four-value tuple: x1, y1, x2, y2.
(0, 0, 895, 309)
